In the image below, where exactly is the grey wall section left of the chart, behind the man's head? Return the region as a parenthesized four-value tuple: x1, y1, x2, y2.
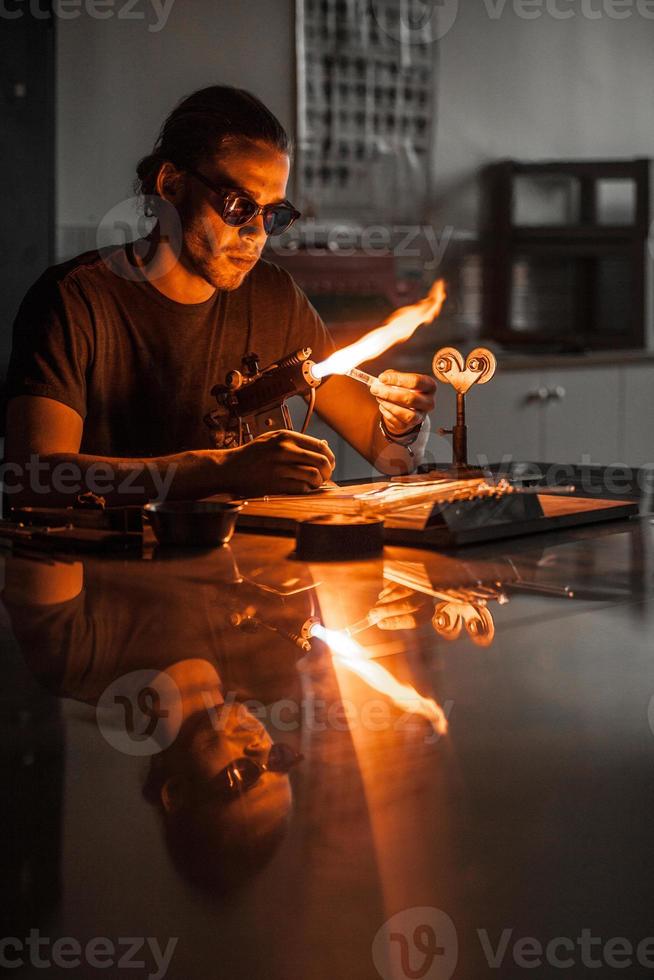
(57, 0, 295, 254)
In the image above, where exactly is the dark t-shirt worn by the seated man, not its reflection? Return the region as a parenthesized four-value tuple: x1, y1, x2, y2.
(6, 246, 333, 457)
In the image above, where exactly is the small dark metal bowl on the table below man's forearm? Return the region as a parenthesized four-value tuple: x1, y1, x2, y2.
(143, 500, 243, 548)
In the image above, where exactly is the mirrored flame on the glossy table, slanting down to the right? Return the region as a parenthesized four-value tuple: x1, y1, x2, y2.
(311, 623, 447, 735)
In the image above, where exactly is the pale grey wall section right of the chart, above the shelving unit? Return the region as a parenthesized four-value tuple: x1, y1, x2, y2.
(434, 0, 654, 228)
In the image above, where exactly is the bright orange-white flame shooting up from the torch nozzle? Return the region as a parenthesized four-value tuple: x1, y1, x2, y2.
(312, 279, 446, 379)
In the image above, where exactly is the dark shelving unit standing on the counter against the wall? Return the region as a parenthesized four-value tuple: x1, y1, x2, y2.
(482, 160, 650, 351)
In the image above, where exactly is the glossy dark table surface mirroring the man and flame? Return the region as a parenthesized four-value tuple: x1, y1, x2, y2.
(0, 519, 654, 980)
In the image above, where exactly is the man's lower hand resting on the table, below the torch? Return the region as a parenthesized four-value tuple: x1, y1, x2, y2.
(221, 429, 336, 497)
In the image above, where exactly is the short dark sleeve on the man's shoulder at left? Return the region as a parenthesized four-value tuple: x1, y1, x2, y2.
(5, 273, 93, 418)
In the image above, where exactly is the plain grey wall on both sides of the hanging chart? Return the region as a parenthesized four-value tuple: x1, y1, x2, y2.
(57, 0, 654, 245)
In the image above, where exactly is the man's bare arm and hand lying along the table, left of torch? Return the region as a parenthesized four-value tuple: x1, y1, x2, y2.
(4, 395, 335, 506)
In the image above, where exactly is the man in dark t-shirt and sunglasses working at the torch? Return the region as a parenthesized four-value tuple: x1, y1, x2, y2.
(5, 86, 435, 504)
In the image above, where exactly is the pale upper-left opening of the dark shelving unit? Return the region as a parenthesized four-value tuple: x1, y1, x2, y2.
(513, 174, 581, 226)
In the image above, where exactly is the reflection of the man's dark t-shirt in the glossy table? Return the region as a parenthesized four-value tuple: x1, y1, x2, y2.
(2, 548, 313, 704)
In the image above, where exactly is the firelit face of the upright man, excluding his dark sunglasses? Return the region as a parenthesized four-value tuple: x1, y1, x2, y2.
(180, 142, 290, 290)
